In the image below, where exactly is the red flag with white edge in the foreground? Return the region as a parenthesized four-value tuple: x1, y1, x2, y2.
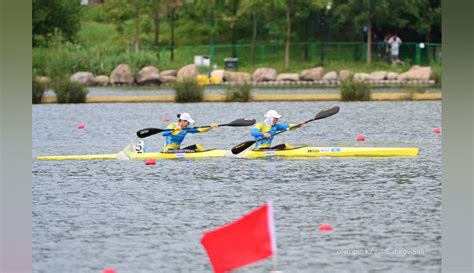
(201, 202, 275, 273)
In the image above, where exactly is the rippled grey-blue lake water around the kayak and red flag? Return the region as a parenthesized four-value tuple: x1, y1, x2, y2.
(32, 101, 441, 273)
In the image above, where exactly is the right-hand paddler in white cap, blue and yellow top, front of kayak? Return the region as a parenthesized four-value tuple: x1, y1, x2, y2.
(251, 110, 304, 150)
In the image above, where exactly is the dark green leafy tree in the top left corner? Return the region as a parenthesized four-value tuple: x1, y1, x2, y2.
(32, 0, 81, 46)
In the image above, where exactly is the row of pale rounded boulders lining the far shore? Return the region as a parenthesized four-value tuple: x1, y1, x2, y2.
(36, 64, 436, 87)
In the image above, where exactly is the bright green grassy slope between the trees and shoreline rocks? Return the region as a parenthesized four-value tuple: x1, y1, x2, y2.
(33, 7, 441, 78)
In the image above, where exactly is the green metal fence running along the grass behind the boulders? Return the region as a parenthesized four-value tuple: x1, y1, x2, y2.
(146, 42, 442, 69)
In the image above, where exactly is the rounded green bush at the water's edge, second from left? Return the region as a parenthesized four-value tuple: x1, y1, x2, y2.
(52, 78, 89, 103)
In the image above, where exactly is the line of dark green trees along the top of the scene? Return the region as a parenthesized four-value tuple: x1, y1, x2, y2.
(33, 0, 441, 67)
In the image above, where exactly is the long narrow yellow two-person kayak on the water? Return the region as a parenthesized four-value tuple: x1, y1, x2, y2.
(36, 146, 418, 160)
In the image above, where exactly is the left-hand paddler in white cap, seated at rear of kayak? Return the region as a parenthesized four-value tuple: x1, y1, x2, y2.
(163, 113, 219, 152)
